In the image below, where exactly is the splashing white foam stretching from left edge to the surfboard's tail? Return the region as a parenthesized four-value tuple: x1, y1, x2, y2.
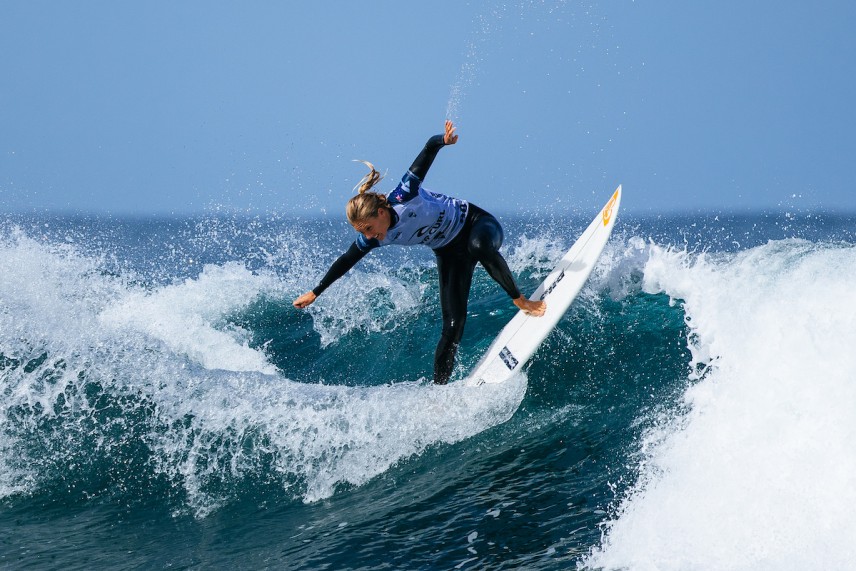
(0, 232, 526, 517)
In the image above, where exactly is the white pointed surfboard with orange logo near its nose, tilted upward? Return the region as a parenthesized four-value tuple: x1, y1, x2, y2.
(463, 185, 621, 385)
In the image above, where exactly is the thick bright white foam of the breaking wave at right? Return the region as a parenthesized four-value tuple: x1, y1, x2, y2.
(584, 240, 856, 571)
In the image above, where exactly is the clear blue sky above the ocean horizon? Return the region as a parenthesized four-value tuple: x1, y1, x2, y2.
(0, 0, 856, 216)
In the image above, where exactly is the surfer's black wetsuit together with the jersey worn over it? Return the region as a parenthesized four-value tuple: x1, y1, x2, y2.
(312, 135, 520, 384)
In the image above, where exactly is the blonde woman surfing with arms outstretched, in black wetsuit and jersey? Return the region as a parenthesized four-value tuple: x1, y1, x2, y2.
(294, 121, 547, 384)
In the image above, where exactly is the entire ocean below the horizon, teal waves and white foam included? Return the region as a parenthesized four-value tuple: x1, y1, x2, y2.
(0, 208, 856, 571)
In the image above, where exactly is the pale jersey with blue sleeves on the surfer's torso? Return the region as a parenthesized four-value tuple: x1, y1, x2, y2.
(356, 171, 469, 252)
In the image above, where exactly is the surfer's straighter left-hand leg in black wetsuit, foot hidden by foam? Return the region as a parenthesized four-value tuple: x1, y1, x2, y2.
(434, 248, 476, 385)
